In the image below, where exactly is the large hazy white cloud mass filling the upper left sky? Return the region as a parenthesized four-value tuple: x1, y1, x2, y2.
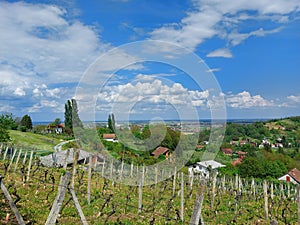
(0, 1, 142, 117)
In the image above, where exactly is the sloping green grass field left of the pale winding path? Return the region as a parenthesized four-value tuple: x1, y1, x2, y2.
(9, 130, 63, 151)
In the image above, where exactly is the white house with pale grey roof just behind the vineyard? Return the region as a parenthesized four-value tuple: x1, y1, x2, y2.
(188, 160, 225, 178)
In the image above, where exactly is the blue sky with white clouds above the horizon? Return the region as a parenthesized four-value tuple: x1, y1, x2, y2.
(0, 0, 300, 121)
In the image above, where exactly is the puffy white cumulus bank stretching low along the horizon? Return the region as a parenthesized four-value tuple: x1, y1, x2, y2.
(74, 74, 300, 119)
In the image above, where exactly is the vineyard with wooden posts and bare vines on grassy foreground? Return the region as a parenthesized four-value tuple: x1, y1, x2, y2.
(0, 144, 300, 224)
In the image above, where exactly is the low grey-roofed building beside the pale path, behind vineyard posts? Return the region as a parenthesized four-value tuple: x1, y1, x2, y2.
(40, 148, 92, 167)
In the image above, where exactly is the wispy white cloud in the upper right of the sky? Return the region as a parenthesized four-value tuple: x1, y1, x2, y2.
(150, 0, 300, 53)
